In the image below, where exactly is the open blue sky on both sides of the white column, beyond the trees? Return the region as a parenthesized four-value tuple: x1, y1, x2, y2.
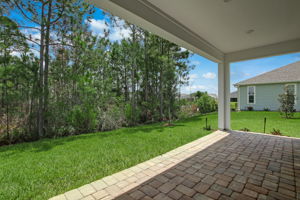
(188, 53, 300, 94)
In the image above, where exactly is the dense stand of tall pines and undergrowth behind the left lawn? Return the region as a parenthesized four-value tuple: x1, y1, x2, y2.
(0, 0, 196, 144)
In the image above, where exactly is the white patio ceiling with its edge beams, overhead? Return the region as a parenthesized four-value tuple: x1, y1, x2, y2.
(91, 0, 300, 62)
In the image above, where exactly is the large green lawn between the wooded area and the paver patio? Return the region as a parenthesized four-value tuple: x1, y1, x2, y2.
(0, 114, 217, 200)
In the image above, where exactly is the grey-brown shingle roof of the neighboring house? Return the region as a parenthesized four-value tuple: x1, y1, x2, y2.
(234, 61, 300, 86)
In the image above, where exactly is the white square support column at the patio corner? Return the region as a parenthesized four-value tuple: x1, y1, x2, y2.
(218, 61, 230, 130)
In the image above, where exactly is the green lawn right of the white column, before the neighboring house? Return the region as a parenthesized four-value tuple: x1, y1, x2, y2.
(231, 111, 300, 137)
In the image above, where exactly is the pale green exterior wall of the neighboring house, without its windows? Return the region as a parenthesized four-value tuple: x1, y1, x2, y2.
(239, 83, 300, 111)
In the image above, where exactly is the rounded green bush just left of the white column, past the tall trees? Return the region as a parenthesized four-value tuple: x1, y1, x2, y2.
(197, 93, 218, 114)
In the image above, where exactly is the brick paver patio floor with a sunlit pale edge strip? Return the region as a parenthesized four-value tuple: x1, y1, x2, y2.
(51, 131, 300, 200)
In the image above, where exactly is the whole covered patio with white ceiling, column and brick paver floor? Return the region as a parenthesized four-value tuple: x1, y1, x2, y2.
(52, 0, 300, 200)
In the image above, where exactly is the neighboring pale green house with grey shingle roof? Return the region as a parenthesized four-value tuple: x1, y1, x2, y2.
(234, 61, 300, 111)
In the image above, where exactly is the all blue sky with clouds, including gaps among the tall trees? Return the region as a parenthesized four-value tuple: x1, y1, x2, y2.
(11, 3, 300, 94)
